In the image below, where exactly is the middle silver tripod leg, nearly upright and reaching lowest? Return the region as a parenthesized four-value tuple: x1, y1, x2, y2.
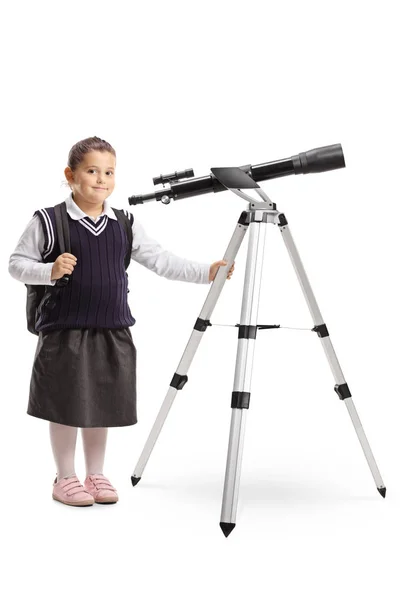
(220, 212, 266, 537)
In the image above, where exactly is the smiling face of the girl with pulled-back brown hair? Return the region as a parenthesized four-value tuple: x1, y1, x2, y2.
(64, 150, 115, 205)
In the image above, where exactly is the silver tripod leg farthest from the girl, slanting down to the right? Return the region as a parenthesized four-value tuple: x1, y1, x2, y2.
(277, 213, 386, 497)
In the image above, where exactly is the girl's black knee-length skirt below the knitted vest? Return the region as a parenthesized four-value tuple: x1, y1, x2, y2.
(27, 327, 137, 427)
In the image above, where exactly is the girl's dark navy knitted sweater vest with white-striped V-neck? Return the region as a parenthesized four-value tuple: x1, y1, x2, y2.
(34, 207, 136, 331)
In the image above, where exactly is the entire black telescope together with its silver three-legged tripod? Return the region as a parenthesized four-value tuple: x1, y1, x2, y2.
(129, 144, 386, 537)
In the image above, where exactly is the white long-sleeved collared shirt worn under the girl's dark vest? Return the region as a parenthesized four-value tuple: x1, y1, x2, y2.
(8, 192, 211, 285)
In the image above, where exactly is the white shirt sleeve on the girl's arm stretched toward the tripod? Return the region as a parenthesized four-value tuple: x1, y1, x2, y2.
(131, 217, 211, 283)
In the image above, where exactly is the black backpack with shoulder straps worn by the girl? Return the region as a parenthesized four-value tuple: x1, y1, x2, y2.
(25, 202, 132, 335)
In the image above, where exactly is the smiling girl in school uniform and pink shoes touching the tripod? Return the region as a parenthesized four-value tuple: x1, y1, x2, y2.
(9, 137, 234, 506)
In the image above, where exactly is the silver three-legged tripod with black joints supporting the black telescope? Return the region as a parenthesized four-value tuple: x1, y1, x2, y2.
(131, 167, 386, 537)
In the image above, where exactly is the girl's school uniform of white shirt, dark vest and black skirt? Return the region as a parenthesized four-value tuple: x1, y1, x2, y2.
(9, 192, 210, 427)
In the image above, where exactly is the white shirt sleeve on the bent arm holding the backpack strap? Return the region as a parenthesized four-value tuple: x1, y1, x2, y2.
(8, 215, 57, 285)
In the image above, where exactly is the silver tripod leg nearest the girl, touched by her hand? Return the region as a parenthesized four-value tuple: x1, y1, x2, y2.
(131, 211, 248, 485)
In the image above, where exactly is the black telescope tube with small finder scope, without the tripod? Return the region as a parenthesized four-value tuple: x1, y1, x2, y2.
(128, 144, 346, 204)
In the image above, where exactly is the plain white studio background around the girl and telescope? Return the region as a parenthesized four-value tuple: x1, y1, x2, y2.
(0, 0, 400, 600)
